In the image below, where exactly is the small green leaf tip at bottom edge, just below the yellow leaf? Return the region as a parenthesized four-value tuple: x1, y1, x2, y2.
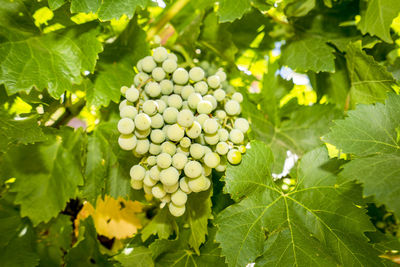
(114, 247, 154, 267)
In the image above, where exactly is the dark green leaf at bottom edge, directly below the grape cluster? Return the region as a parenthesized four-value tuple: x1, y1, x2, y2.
(150, 227, 226, 267)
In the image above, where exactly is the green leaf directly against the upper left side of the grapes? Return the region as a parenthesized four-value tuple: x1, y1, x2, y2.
(86, 20, 149, 106)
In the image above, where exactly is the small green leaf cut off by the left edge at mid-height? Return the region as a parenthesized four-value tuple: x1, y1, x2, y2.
(0, 109, 46, 152)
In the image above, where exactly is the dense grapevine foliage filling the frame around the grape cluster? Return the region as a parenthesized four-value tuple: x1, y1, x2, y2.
(0, 0, 400, 266)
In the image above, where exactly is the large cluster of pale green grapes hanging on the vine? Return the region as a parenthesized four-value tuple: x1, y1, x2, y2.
(118, 47, 249, 217)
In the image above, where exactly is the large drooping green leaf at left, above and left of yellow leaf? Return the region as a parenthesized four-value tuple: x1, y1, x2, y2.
(6, 128, 85, 225)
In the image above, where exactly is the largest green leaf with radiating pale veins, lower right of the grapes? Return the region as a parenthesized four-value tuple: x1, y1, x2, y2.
(216, 141, 381, 266)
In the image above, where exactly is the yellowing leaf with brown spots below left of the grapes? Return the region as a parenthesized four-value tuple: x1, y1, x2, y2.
(75, 196, 142, 239)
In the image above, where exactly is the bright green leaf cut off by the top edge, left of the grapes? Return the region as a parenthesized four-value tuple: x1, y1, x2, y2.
(71, 0, 148, 20)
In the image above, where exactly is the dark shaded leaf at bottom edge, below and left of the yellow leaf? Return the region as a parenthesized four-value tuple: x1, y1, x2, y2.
(37, 214, 72, 267)
